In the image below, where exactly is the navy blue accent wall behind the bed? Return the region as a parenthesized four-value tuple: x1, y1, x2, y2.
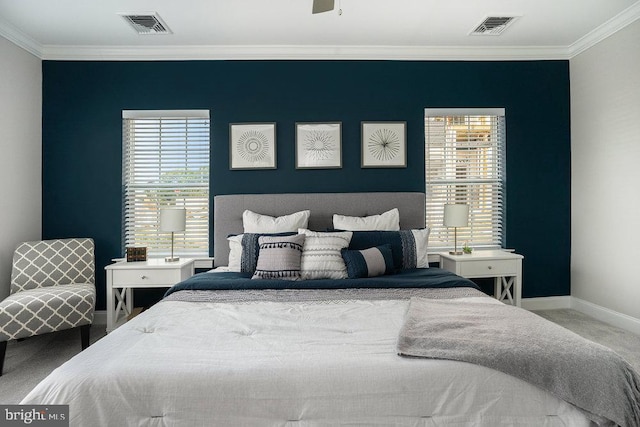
(42, 61, 570, 309)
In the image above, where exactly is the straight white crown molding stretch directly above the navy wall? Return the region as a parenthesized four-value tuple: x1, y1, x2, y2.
(42, 45, 567, 61)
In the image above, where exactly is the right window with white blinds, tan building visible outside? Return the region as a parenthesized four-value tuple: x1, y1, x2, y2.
(425, 109, 506, 250)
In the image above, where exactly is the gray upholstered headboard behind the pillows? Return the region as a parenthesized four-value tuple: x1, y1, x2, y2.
(213, 192, 425, 267)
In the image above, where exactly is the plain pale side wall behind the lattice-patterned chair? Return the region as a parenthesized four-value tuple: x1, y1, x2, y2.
(0, 37, 42, 298)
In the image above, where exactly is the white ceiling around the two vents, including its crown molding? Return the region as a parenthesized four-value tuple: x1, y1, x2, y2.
(0, 0, 640, 60)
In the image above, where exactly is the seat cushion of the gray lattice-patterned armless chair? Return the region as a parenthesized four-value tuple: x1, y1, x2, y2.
(0, 283, 96, 342)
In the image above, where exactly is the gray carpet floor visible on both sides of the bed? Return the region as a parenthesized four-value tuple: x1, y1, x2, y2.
(0, 309, 640, 404)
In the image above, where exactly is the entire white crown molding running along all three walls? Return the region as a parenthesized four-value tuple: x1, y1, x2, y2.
(0, 2, 640, 61)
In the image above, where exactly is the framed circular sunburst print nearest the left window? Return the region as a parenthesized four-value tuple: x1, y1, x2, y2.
(229, 123, 277, 170)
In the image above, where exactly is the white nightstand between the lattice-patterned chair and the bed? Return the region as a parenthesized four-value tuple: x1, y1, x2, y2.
(104, 258, 194, 332)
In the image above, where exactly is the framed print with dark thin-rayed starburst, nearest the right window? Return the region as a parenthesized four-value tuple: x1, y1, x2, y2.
(361, 121, 407, 168)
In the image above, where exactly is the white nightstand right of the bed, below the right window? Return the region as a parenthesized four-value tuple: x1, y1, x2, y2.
(440, 250, 524, 307)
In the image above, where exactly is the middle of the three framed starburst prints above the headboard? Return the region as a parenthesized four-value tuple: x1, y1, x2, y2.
(296, 122, 342, 169)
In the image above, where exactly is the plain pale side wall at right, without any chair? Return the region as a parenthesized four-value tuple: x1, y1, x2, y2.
(570, 20, 640, 319)
